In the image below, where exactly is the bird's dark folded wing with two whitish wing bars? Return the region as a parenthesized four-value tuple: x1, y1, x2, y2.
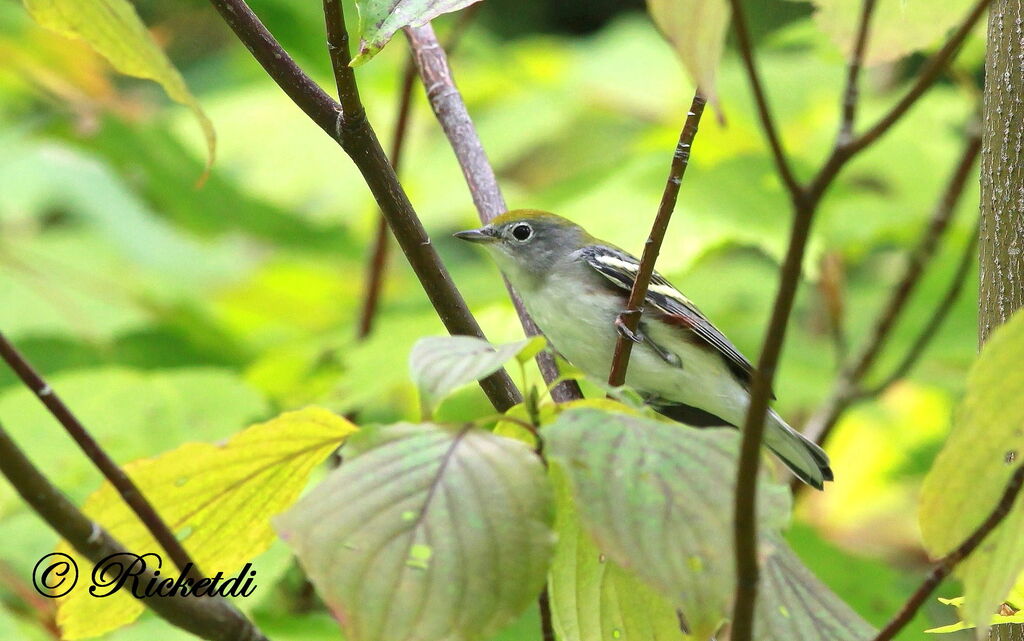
(578, 245, 754, 384)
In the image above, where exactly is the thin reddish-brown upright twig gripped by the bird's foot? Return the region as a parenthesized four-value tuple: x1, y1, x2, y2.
(608, 88, 708, 387)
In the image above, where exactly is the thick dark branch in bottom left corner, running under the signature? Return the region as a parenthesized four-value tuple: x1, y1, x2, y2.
(0, 419, 266, 641)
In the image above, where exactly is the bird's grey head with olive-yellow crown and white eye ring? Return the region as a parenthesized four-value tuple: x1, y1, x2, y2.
(455, 209, 591, 287)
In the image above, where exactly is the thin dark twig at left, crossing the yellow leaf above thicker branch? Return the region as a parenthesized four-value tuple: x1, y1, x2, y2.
(0, 332, 201, 576)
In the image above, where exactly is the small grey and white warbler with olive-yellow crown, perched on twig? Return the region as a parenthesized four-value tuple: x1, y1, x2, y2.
(455, 210, 833, 489)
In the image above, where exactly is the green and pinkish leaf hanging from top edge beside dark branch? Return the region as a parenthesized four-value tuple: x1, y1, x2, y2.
(352, 0, 480, 67)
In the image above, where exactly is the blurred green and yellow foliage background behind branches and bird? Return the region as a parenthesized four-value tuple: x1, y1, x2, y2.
(0, 0, 984, 640)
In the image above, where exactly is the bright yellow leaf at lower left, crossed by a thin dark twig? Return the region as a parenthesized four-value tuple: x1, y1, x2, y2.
(57, 408, 356, 639)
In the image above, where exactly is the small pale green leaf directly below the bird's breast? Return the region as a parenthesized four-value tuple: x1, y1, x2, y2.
(409, 336, 535, 410)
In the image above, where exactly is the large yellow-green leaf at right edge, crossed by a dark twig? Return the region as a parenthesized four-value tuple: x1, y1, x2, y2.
(921, 313, 1024, 634)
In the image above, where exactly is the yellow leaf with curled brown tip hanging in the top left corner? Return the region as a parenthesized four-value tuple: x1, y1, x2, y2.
(24, 0, 217, 169)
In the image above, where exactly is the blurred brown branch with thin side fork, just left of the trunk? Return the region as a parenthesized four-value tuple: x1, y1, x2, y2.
(804, 127, 981, 444)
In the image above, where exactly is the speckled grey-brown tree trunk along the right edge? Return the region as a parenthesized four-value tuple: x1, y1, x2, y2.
(978, 0, 1024, 641)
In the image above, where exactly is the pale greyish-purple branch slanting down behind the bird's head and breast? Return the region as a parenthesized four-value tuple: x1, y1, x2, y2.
(404, 21, 583, 402)
